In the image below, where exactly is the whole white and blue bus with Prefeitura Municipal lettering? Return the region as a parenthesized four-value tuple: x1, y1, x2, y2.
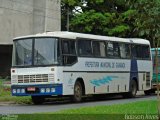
(11, 31, 152, 104)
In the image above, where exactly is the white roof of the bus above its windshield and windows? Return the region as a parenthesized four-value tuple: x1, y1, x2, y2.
(14, 31, 150, 44)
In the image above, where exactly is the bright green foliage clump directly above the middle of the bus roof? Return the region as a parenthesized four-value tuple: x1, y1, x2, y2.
(70, 10, 135, 37)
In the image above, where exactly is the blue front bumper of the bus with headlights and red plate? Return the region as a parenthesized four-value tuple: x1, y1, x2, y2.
(11, 84, 63, 96)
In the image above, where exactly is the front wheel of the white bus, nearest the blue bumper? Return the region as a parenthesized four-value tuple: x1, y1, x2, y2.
(72, 81, 82, 102)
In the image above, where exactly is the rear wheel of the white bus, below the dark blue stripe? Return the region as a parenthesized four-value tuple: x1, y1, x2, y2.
(128, 80, 138, 98)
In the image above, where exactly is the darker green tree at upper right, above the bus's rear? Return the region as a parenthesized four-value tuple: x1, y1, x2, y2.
(128, 0, 160, 47)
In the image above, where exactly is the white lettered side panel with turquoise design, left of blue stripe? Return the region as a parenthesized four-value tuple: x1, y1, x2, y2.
(63, 58, 130, 94)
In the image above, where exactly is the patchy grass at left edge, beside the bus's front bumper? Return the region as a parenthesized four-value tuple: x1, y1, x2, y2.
(0, 79, 32, 104)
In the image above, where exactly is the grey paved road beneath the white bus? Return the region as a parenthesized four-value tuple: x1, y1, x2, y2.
(0, 94, 157, 114)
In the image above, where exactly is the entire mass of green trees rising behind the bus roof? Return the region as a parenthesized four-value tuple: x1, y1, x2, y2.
(62, 0, 160, 46)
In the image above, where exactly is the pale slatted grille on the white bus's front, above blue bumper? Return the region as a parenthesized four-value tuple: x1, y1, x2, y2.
(18, 74, 53, 83)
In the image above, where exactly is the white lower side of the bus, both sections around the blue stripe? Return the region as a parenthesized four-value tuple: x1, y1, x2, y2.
(63, 58, 152, 95)
